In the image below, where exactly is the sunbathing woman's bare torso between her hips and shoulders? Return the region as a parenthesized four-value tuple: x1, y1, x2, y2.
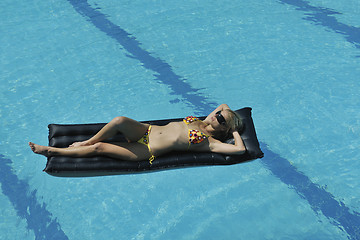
(149, 120, 208, 155)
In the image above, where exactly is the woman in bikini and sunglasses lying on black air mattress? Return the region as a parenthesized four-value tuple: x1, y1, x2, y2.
(29, 104, 245, 163)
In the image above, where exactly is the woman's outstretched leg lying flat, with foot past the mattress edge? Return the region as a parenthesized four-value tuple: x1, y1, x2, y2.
(29, 142, 151, 161)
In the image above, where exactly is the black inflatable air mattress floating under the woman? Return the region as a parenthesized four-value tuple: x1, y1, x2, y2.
(44, 107, 264, 177)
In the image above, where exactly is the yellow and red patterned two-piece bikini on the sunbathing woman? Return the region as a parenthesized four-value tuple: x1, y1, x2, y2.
(138, 116, 209, 164)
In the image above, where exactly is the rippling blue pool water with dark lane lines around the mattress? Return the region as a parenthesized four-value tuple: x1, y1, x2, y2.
(0, 0, 360, 239)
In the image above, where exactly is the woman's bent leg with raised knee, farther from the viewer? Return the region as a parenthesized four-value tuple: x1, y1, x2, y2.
(70, 117, 149, 147)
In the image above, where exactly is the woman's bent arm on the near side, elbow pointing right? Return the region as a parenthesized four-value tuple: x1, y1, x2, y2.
(209, 131, 246, 155)
